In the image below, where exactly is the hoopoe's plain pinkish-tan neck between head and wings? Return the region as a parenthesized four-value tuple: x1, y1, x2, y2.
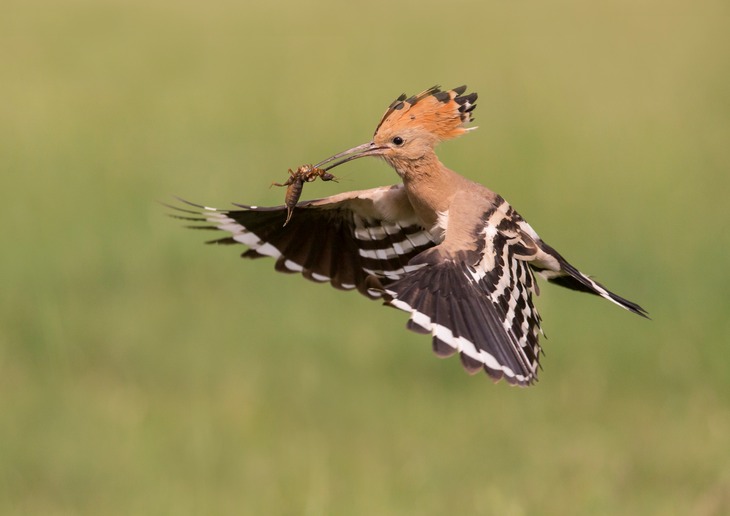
(391, 152, 462, 229)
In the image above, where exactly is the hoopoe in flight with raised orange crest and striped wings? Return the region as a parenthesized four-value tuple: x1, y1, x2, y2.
(173, 86, 647, 386)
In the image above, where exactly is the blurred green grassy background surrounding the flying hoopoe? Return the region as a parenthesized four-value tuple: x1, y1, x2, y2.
(0, 0, 730, 515)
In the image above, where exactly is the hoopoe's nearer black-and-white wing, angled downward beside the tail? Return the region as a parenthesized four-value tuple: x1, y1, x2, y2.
(376, 203, 541, 385)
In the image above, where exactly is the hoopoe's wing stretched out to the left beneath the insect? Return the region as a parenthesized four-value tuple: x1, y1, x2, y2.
(168, 185, 437, 298)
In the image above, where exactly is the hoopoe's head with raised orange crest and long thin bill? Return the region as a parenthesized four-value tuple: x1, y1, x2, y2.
(317, 86, 477, 172)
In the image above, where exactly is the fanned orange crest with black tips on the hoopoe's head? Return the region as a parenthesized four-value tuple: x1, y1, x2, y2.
(375, 86, 477, 141)
